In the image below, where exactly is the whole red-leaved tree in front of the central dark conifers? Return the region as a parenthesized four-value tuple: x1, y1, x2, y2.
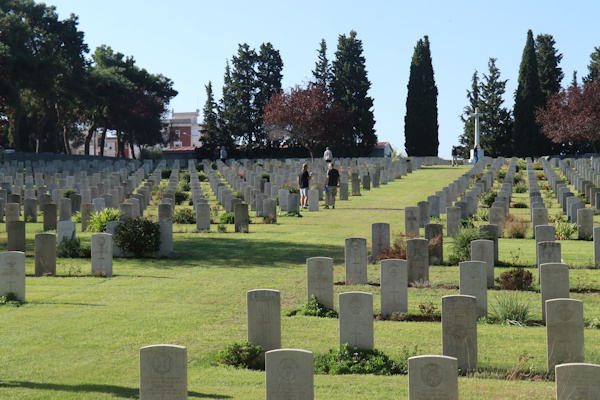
(263, 84, 352, 159)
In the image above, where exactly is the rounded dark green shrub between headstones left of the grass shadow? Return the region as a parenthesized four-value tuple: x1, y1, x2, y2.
(114, 217, 160, 258)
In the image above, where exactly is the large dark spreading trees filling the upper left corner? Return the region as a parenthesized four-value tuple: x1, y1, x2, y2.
(0, 0, 177, 156)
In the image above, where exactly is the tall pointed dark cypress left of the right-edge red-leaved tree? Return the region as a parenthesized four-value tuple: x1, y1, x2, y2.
(513, 29, 549, 157)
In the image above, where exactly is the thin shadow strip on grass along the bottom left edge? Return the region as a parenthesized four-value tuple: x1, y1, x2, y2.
(0, 381, 232, 399)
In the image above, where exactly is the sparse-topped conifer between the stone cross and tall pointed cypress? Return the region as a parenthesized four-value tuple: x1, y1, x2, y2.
(479, 58, 512, 157)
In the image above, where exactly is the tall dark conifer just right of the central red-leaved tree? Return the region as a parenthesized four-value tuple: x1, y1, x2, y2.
(331, 31, 377, 155)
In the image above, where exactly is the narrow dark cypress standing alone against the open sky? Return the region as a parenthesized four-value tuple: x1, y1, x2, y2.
(404, 36, 439, 156)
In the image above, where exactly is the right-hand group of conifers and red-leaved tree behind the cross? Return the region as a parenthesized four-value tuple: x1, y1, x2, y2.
(458, 30, 600, 157)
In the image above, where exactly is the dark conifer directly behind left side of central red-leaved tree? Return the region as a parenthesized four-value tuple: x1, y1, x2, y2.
(254, 43, 283, 145)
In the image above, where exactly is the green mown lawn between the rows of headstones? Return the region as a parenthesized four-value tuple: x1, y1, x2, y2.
(0, 161, 600, 399)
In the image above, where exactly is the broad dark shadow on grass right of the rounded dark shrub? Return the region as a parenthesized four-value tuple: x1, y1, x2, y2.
(175, 233, 344, 268)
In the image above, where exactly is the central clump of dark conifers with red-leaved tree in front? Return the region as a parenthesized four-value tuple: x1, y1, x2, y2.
(201, 31, 377, 156)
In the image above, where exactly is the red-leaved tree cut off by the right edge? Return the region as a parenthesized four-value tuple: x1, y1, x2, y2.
(536, 82, 600, 152)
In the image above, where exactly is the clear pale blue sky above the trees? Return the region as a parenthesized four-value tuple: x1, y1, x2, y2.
(46, 0, 600, 158)
